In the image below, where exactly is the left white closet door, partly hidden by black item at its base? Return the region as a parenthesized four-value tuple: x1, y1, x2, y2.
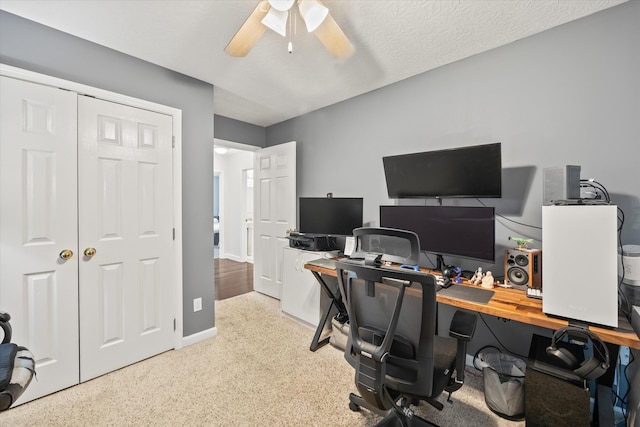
(0, 77, 79, 402)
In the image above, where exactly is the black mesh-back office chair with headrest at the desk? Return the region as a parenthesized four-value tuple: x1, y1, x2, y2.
(336, 228, 477, 426)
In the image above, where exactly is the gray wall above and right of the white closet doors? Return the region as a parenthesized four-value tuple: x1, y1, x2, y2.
(0, 11, 215, 336)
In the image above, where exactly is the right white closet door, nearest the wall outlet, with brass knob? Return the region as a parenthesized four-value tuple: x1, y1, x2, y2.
(78, 96, 175, 381)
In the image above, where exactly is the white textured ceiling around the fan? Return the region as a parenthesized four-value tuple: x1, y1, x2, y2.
(0, 0, 626, 126)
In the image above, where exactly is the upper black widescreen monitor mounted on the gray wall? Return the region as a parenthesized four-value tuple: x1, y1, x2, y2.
(382, 142, 502, 199)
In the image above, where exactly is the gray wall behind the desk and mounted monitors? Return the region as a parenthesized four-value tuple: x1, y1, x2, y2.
(267, 0, 640, 354)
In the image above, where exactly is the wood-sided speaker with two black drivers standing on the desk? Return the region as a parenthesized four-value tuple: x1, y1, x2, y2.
(504, 248, 542, 298)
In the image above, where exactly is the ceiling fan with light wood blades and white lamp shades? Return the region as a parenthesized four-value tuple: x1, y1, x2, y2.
(224, 0, 355, 59)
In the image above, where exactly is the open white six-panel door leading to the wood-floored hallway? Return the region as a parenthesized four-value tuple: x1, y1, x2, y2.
(253, 141, 296, 299)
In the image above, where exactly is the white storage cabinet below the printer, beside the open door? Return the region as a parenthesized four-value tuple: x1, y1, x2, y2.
(280, 247, 336, 327)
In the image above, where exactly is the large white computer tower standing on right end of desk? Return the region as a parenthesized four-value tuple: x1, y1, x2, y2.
(542, 205, 618, 327)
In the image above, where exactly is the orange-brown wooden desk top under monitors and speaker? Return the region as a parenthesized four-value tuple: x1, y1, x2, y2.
(304, 264, 640, 349)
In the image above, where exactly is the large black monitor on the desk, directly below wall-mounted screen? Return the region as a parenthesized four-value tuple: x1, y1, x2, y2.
(380, 205, 495, 269)
